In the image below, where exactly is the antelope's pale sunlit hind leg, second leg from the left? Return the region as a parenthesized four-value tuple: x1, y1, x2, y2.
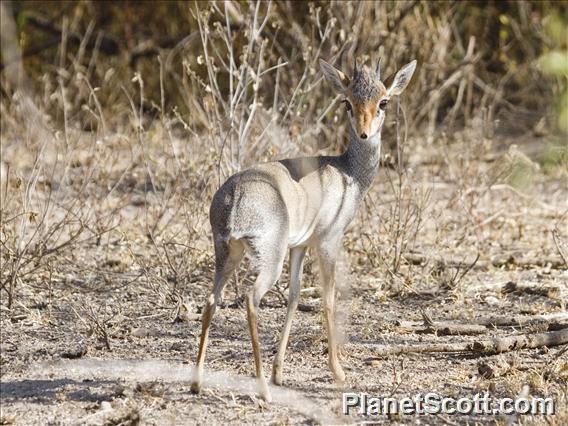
(247, 240, 286, 402)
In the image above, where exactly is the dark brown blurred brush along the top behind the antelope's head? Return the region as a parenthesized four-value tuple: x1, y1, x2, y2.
(1, 0, 568, 145)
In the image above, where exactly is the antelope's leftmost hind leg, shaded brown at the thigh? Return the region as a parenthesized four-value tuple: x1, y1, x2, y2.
(191, 241, 244, 393)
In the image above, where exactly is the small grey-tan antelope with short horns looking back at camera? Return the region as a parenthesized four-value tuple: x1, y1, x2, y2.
(191, 55, 416, 402)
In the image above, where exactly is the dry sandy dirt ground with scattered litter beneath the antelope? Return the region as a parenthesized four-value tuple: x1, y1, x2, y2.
(0, 132, 568, 425)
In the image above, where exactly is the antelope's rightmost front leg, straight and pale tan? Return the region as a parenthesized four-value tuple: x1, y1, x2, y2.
(318, 244, 345, 382)
